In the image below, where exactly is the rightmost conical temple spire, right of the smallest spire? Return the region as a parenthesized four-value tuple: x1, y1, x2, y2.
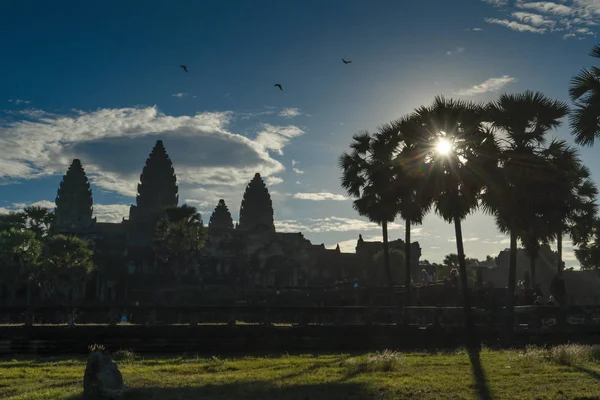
(239, 173, 275, 231)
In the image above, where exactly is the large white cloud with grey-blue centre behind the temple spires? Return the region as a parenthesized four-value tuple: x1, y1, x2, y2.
(0, 107, 304, 197)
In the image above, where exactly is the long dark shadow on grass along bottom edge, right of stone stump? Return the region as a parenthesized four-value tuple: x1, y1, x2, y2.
(65, 381, 381, 400)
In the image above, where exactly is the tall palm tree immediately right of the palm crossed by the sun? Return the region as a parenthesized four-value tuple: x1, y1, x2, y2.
(483, 91, 568, 306)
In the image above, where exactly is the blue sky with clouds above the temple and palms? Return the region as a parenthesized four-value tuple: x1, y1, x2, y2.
(0, 0, 600, 265)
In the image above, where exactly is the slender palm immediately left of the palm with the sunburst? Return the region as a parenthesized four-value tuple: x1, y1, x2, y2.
(378, 116, 432, 306)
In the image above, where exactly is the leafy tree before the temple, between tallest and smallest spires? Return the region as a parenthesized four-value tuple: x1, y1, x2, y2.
(154, 204, 206, 284)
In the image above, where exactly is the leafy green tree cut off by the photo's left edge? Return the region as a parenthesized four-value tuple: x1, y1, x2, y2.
(0, 227, 41, 304)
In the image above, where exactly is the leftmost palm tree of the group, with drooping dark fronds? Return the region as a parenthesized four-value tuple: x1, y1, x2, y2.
(338, 128, 398, 298)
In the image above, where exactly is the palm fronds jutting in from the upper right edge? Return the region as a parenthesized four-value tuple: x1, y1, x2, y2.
(569, 45, 600, 146)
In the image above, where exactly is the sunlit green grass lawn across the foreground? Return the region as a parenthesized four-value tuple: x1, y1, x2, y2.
(0, 345, 600, 400)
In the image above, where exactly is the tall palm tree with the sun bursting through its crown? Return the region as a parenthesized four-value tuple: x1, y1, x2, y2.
(406, 97, 498, 338)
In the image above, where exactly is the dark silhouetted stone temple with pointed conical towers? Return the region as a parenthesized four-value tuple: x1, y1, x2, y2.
(55, 140, 421, 302)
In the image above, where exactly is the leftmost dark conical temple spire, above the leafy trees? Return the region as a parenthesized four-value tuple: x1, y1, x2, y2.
(54, 159, 93, 232)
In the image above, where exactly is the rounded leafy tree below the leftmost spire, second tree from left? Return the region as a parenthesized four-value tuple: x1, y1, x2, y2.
(41, 235, 94, 297)
